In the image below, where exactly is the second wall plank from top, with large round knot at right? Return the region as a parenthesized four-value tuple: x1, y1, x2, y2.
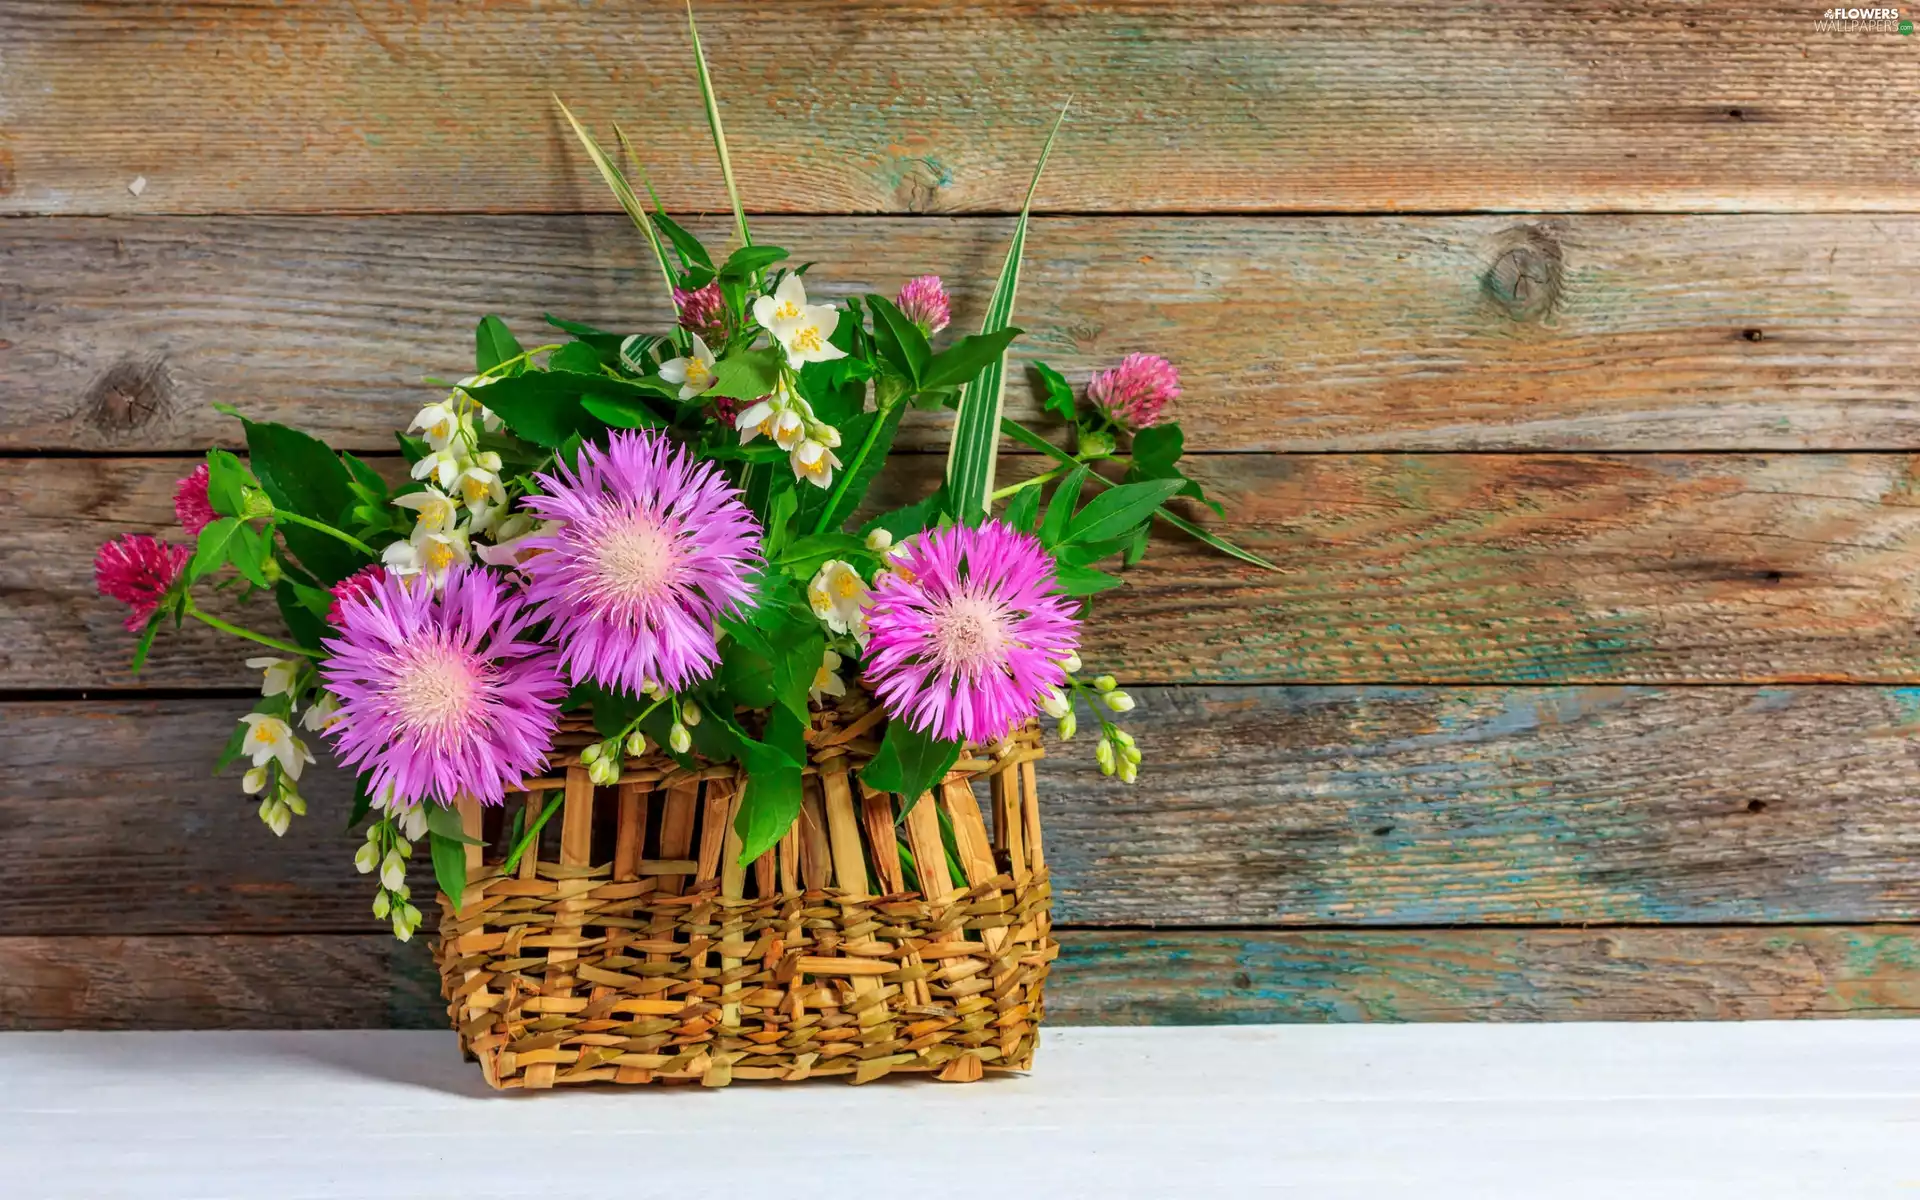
(0, 215, 1920, 451)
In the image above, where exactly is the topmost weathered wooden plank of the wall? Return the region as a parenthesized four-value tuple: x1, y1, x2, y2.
(0, 0, 1920, 213)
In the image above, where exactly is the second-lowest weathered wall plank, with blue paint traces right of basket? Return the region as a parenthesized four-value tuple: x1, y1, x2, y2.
(0, 687, 1920, 935)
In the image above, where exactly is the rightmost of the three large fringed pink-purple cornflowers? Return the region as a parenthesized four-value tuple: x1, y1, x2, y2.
(866, 520, 1079, 743)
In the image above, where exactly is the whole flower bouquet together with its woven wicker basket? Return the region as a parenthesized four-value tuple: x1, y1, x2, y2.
(96, 11, 1258, 1089)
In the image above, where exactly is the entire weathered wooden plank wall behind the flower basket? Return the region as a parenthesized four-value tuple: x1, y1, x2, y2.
(0, 0, 1920, 1027)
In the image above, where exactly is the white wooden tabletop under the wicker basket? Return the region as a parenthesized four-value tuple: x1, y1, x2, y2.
(0, 1021, 1920, 1200)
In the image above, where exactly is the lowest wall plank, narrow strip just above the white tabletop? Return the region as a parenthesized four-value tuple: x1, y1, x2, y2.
(0, 925, 1920, 1029)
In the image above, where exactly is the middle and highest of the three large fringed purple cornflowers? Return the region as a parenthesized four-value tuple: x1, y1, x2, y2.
(522, 430, 760, 693)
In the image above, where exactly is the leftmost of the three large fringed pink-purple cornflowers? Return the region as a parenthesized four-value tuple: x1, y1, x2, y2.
(321, 566, 566, 810)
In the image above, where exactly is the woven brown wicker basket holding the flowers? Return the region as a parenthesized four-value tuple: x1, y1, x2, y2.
(438, 695, 1058, 1089)
